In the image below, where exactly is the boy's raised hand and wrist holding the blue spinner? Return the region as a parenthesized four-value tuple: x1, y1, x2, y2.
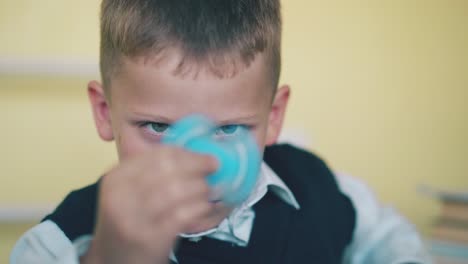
(81, 145, 217, 264)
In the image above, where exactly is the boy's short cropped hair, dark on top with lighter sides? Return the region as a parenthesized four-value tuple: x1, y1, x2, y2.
(100, 0, 281, 94)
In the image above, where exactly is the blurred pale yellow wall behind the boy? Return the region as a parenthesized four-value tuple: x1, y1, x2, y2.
(0, 0, 468, 263)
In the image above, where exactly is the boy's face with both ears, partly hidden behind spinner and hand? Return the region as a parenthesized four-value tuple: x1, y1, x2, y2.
(88, 51, 289, 160)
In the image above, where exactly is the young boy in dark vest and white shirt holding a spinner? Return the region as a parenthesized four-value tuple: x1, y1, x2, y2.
(11, 0, 427, 264)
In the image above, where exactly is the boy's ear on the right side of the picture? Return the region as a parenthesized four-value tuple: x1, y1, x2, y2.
(265, 85, 291, 146)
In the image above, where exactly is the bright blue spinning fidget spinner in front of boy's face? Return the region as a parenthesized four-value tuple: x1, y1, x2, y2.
(162, 115, 261, 205)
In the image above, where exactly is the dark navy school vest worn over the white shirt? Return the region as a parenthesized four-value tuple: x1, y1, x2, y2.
(43, 145, 355, 264)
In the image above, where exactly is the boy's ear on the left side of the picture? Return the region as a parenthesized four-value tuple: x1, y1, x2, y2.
(88, 81, 114, 141)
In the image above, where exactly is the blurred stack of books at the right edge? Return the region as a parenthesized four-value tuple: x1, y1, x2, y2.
(425, 189, 468, 264)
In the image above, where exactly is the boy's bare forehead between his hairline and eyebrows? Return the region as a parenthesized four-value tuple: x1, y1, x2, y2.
(111, 48, 273, 119)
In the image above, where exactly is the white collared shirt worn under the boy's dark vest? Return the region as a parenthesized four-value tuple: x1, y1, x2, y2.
(10, 163, 431, 264)
